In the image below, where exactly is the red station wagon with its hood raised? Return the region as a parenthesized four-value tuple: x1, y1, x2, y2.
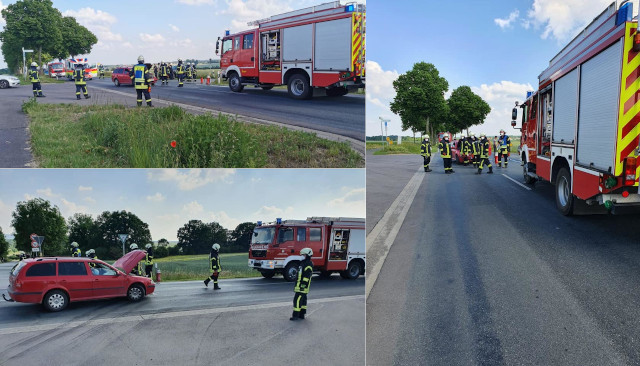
(8, 250, 156, 311)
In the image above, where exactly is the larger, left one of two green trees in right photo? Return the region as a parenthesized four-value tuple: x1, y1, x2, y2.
(391, 62, 449, 137)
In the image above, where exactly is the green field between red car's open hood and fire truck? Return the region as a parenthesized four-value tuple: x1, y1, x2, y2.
(155, 253, 260, 281)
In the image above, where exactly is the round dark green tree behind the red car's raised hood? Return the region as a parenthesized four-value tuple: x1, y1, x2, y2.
(95, 211, 151, 258)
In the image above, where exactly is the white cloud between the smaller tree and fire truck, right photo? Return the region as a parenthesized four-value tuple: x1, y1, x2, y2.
(470, 81, 534, 135)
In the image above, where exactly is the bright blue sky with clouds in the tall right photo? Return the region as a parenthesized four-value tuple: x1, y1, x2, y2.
(366, 0, 638, 136)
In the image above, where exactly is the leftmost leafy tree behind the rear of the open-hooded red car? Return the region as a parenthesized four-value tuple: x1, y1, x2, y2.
(11, 198, 68, 255)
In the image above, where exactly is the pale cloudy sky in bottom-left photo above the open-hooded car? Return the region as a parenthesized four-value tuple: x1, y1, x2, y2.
(0, 169, 365, 240)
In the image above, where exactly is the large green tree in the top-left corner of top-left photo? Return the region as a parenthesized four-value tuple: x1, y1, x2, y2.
(0, 0, 62, 72)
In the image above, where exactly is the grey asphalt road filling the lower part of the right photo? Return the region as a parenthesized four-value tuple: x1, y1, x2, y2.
(366, 154, 640, 365)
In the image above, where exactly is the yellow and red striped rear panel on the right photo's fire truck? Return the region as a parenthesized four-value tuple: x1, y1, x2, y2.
(615, 22, 640, 182)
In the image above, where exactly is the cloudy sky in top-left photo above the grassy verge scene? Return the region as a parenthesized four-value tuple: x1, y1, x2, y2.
(0, 0, 364, 68)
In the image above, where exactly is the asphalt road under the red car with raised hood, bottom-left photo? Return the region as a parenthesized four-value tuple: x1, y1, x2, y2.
(0, 264, 365, 366)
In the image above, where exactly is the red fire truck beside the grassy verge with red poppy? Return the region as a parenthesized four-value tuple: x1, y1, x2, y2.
(216, 1, 365, 99)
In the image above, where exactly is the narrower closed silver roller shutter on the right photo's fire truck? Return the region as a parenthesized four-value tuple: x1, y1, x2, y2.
(553, 69, 578, 144)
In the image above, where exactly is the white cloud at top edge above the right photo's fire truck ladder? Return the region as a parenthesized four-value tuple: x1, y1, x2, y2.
(527, 0, 612, 41)
